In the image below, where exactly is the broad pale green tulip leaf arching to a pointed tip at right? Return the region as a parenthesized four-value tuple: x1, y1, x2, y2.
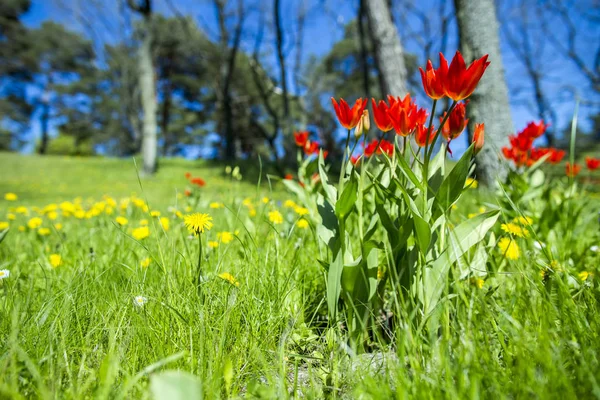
(421, 211, 500, 315)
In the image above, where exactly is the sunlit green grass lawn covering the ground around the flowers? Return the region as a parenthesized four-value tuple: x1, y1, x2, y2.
(0, 154, 600, 399)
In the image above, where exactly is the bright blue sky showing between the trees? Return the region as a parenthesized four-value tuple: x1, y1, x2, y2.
(16, 0, 600, 156)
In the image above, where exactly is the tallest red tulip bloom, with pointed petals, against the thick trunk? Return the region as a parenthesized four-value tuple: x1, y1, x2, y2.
(442, 51, 490, 101)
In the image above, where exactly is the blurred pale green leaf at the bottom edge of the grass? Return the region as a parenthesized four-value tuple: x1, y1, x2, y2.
(150, 371, 204, 400)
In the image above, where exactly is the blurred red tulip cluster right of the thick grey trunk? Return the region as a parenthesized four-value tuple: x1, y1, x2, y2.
(502, 121, 565, 167)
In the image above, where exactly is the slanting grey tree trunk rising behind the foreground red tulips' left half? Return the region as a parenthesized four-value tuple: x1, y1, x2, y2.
(364, 0, 407, 96)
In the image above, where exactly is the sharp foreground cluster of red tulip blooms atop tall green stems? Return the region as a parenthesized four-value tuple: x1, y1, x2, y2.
(324, 51, 489, 163)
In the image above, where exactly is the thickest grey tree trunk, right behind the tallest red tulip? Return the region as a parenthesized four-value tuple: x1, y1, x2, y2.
(454, 0, 513, 186)
